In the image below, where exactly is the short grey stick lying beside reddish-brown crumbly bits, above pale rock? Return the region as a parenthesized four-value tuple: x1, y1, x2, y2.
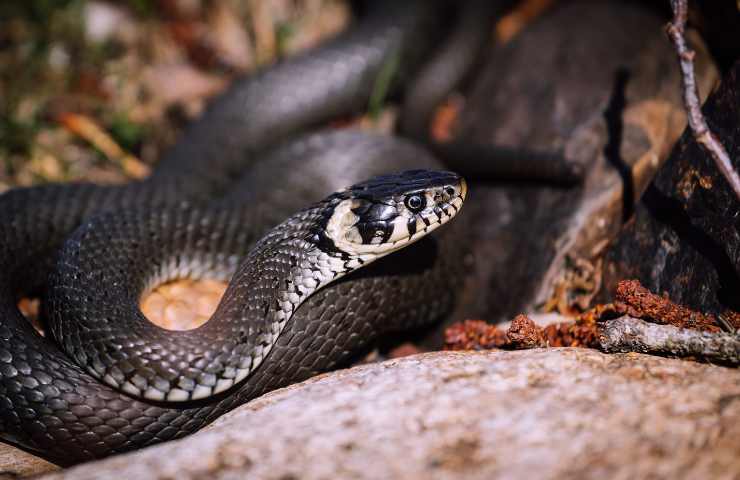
(599, 315, 740, 366)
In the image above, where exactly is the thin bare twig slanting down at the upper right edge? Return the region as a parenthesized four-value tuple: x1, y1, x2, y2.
(666, 0, 740, 199)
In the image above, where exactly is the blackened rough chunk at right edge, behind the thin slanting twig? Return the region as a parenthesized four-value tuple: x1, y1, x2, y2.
(602, 62, 740, 313)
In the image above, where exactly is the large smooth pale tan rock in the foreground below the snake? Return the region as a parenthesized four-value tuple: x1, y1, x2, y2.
(39, 348, 740, 479)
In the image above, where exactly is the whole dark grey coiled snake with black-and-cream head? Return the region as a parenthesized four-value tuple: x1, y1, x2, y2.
(0, 0, 488, 465)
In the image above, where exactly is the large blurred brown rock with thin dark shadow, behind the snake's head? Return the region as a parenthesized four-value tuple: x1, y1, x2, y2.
(454, 1, 717, 321)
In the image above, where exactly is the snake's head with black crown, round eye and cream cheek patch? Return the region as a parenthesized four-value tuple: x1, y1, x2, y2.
(324, 170, 467, 257)
